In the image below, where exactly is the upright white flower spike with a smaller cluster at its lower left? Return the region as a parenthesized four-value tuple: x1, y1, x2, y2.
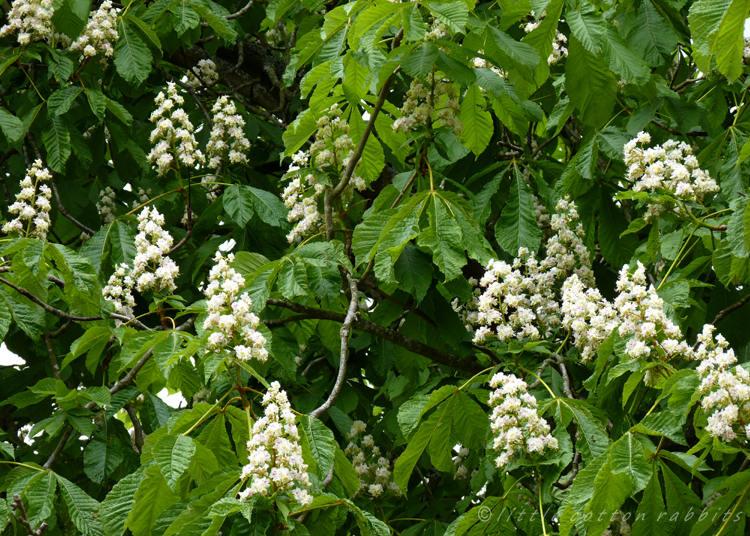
(130, 207, 180, 293)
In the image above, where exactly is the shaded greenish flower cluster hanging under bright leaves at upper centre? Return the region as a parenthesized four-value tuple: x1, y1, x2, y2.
(393, 72, 464, 136)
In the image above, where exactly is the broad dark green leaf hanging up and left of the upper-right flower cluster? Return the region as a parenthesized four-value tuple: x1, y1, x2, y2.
(565, 36, 620, 128)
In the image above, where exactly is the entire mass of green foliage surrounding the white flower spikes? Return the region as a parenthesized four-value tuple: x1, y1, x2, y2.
(0, 0, 750, 536)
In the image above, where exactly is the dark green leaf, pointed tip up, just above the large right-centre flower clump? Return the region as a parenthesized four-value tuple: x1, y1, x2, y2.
(495, 168, 542, 255)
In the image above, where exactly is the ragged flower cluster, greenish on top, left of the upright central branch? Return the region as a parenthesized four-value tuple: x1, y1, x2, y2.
(281, 105, 367, 244)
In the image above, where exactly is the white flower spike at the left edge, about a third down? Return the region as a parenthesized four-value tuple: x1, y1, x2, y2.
(3, 160, 52, 240)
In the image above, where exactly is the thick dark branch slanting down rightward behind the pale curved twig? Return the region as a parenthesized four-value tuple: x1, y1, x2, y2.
(266, 298, 484, 374)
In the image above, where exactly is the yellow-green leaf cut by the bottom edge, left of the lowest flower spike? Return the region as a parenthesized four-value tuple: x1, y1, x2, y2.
(126, 465, 179, 536)
